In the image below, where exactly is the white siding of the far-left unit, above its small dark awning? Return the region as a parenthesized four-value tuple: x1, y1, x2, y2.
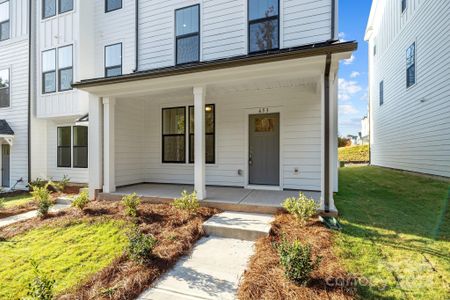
(0, 37, 28, 188)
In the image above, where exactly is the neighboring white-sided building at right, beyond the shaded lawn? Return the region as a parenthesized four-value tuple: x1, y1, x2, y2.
(365, 0, 450, 177)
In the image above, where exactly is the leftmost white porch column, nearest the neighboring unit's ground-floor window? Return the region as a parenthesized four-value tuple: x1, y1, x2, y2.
(88, 95, 103, 200)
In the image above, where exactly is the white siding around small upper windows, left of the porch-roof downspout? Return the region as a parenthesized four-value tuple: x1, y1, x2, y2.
(91, 0, 135, 77)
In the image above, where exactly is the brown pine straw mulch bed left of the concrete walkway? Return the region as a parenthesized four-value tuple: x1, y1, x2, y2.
(0, 201, 218, 300)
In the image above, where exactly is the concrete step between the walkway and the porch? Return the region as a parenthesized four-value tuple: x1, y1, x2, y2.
(203, 211, 273, 241)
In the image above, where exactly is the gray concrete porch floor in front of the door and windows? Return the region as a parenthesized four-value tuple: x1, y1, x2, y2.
(112, 183, 320, 208)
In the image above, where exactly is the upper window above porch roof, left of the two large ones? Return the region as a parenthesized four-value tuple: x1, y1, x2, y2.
(175, 5, 200, 64)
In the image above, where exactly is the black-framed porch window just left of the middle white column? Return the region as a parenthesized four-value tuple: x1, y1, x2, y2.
(162, 107, 186, 163)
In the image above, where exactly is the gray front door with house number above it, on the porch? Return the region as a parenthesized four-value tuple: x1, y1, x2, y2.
(248, 113, 280, 186)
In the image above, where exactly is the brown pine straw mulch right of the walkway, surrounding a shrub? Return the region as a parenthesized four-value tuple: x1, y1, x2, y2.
(238, 213, 355, 300)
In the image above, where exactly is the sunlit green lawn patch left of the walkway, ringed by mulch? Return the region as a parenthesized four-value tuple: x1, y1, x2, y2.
(0, 221, 126, 299)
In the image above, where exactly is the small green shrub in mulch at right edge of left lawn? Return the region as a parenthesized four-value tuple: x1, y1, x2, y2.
(128, 228, 157, 263)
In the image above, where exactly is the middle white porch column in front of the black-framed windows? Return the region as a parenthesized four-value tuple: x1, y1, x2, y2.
(193, 87, 206, 200)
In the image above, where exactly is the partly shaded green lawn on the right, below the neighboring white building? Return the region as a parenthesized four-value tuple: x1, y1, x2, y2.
(335, 167, 450, 299)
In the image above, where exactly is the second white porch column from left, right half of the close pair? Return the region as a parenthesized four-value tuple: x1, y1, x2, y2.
(103, 98, 116, 193)
